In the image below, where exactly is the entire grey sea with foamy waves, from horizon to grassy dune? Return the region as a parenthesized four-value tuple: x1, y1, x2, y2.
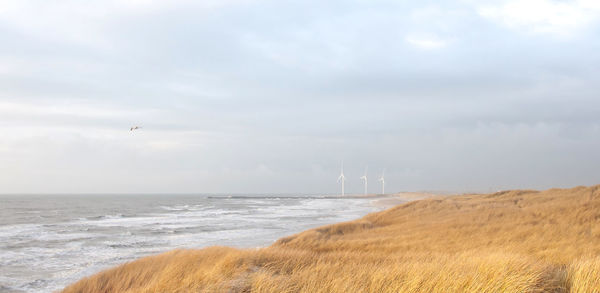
(0, 194, 382, 293)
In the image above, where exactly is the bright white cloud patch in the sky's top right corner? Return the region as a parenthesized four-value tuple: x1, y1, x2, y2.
(477, 0, 600, 37)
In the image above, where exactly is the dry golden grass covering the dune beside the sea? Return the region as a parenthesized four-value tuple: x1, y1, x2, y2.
(63, 186, 600, 293)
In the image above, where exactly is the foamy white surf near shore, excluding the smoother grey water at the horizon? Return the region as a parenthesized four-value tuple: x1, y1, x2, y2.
(0, 197, 374, 292)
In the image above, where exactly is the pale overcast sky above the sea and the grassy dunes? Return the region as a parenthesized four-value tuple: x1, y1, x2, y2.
(0, 0, 600, 194)
